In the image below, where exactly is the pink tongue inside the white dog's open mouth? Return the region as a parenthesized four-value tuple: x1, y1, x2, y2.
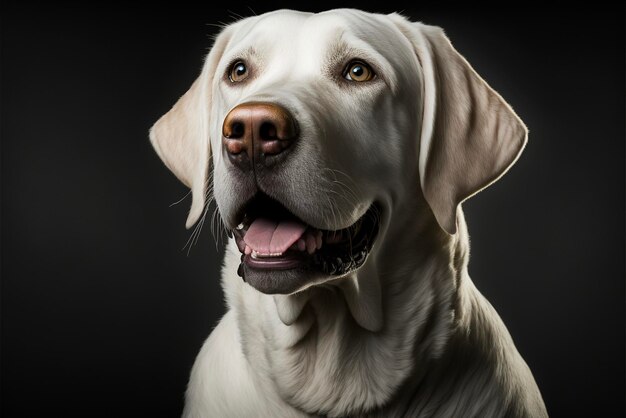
(243, 218, 306, 255)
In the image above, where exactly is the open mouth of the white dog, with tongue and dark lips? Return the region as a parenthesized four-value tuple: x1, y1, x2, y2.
(233, 193, 380, 279)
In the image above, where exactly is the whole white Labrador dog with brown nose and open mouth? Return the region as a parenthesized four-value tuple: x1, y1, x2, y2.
(150, 9, 547, 418)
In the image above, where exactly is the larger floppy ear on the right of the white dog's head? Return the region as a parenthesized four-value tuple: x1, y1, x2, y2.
(390, 14, 528, 234)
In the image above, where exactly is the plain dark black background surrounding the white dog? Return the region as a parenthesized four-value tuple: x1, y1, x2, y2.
(0, 2, 625, 417)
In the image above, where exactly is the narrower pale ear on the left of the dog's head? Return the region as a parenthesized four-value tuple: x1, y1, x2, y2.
(150, 28, 230, 229)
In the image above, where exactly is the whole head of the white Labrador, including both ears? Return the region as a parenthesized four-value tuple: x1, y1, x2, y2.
(151, 10, 526, 293)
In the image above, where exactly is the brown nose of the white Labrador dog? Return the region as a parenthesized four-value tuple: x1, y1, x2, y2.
(222, 102, 298, 170)
